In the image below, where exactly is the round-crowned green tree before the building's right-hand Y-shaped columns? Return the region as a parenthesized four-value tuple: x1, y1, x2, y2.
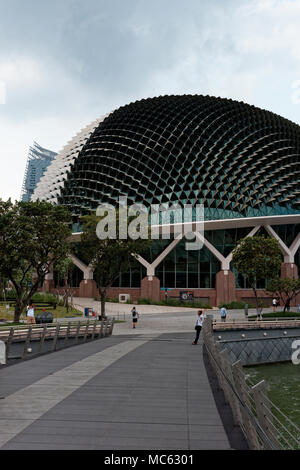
(232, 236, 282, 310)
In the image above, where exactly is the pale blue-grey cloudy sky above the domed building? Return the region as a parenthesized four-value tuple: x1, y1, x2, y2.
(0, 0, 300, 200)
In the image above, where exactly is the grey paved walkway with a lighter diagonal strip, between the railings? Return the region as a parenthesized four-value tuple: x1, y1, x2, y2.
(0, 312, 245, 450)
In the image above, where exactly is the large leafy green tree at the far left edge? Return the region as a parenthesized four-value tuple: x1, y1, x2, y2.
(0, 199, 71, 322)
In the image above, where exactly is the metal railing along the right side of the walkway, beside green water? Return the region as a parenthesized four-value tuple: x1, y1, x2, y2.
(202, 316, 300, 450)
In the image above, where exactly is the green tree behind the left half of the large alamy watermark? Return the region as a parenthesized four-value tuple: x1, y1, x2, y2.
(81, 211, 151, 317)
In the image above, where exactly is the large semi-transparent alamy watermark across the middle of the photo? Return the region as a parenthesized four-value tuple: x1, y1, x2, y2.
(96, 196, 204, 250)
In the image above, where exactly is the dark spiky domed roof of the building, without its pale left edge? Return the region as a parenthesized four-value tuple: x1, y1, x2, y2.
(58, 95, 300, 220)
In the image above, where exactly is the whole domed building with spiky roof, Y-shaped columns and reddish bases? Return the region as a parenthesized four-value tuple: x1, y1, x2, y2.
(32, 95, 300, 306)
